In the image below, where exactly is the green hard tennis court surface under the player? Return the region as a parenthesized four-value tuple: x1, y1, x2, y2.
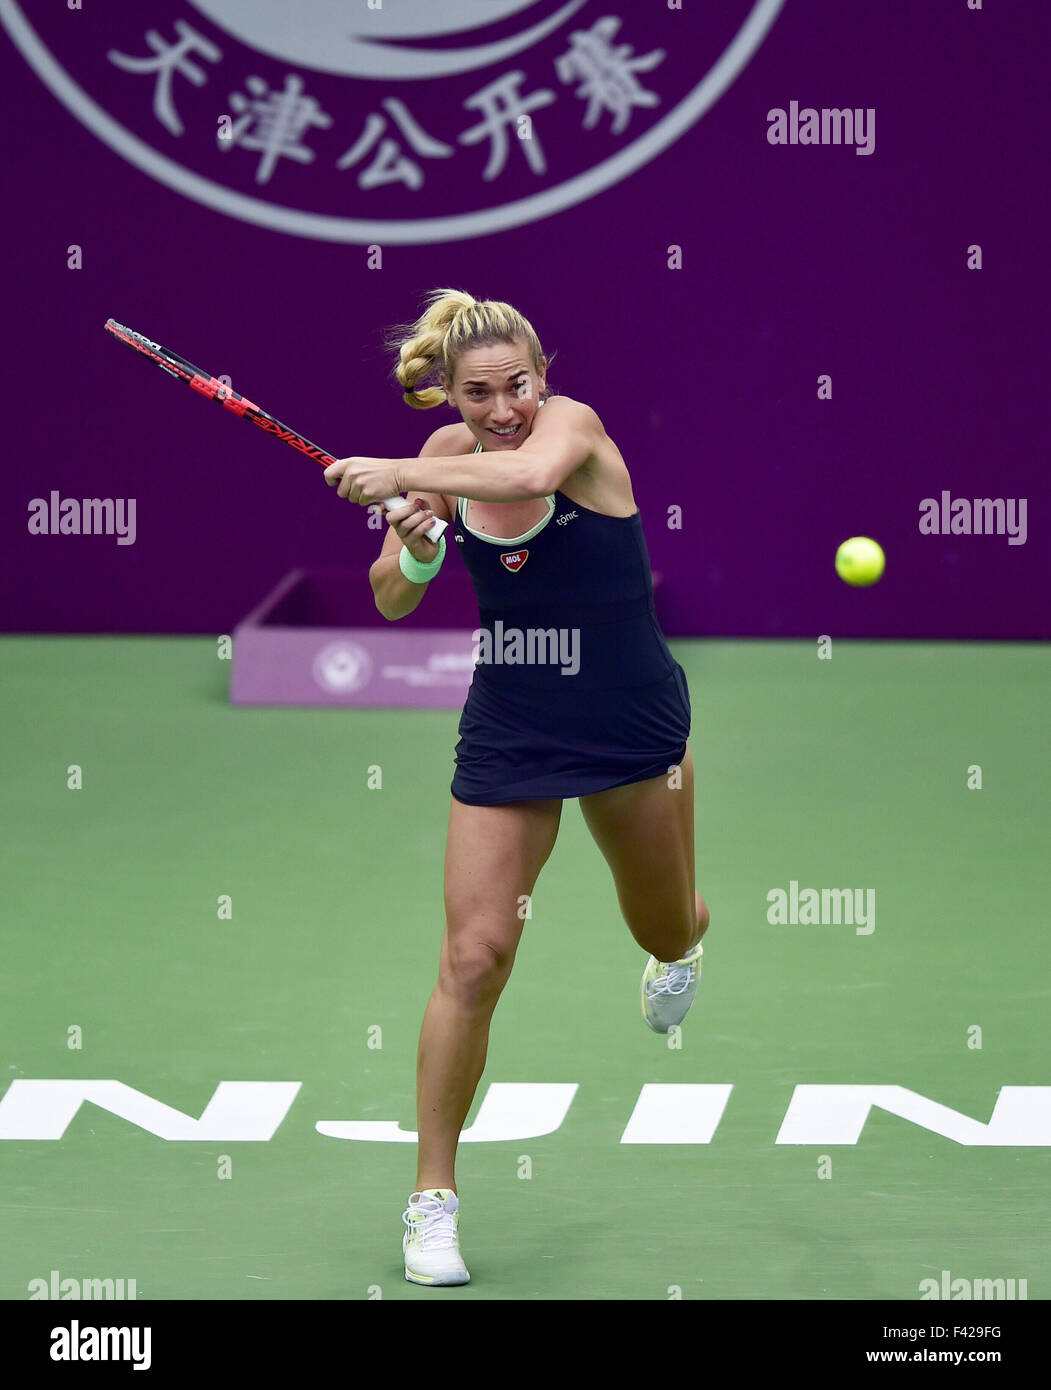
(0, 637, 1051, 1301)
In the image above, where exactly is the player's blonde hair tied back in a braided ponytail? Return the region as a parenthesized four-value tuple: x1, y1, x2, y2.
(386, 289, 551, 410)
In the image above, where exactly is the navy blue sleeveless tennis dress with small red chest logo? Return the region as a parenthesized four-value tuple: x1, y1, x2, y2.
(450, 428, 691, 806)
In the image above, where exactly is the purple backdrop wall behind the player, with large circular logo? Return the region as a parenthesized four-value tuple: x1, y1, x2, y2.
(0, 0, 1051, 639)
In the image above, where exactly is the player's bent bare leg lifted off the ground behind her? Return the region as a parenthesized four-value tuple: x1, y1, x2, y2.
(580, 745, 709, 960)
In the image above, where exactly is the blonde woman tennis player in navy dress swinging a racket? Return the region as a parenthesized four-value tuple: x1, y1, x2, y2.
(325, 289, 709, 1284)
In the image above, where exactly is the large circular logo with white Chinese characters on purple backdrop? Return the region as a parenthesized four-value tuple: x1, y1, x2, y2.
(0, 0, 784, 245)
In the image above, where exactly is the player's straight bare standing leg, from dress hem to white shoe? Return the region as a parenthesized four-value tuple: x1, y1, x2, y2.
(416, 798, 562, 1193)
